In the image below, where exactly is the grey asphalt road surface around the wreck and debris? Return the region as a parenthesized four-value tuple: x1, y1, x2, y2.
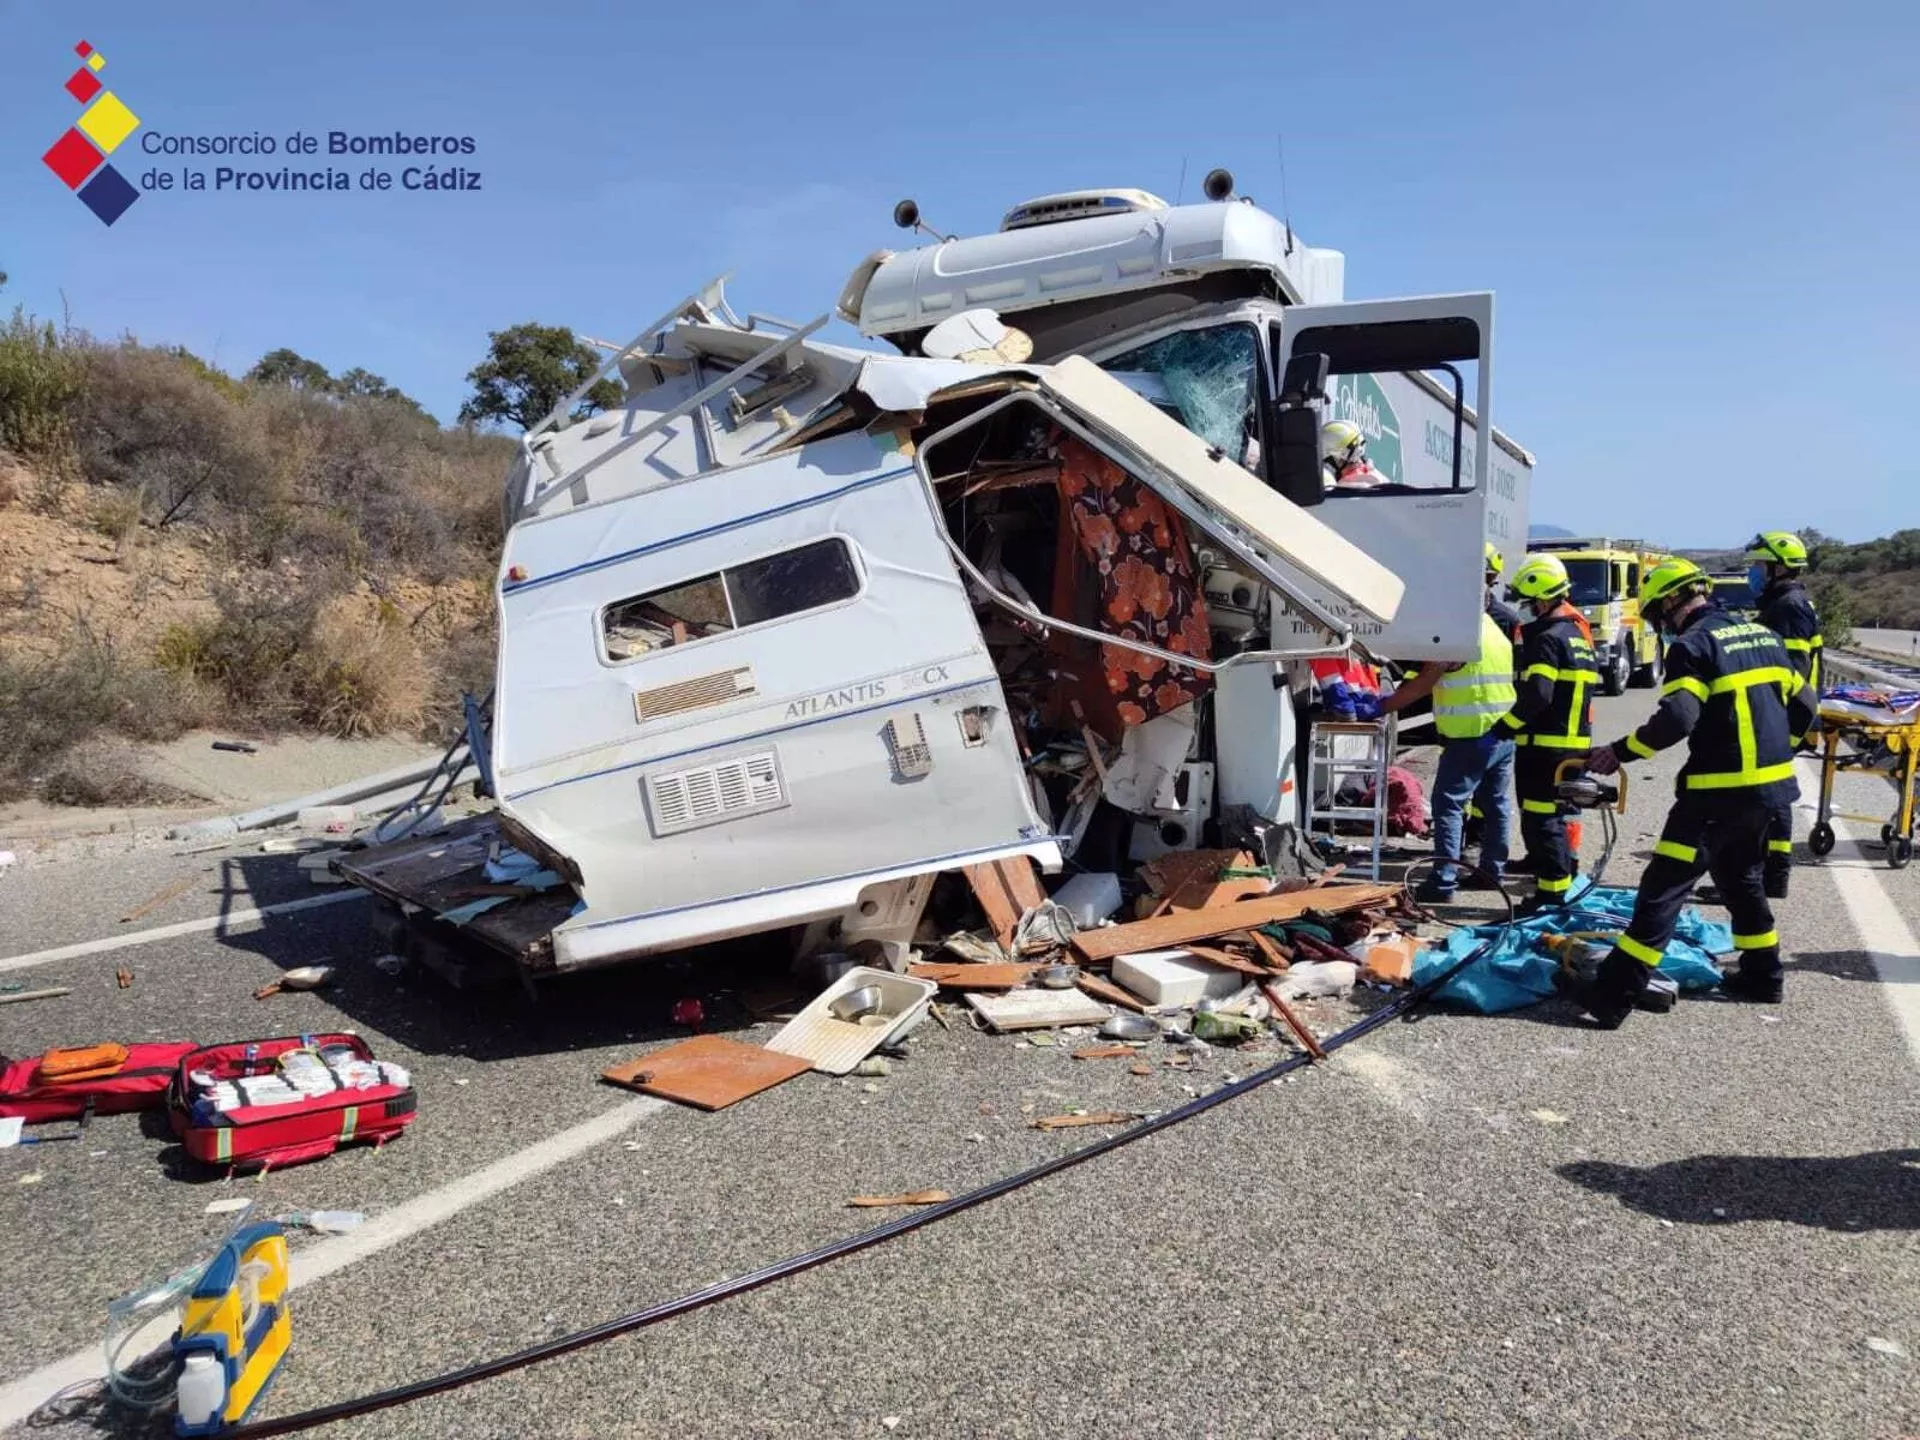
(0, 691, 1920, 1440)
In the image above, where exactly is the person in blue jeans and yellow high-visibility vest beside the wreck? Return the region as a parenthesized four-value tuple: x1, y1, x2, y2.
(1380, 614, 1515, 904)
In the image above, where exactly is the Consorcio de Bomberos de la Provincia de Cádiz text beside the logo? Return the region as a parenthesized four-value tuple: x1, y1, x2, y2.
(140, 129, 480, 194)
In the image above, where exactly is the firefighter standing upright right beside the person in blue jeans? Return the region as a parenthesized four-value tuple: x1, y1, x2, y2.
(1500, 555, 1599, 916)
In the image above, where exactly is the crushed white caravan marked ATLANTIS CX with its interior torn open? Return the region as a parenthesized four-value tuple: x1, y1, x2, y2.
(340, 180, 1528, 973)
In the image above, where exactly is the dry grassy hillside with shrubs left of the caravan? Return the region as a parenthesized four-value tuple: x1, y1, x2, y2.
(0, 313, 513, 804)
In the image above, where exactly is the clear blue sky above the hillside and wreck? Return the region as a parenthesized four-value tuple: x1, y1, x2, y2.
(0, 0, 1920, 545)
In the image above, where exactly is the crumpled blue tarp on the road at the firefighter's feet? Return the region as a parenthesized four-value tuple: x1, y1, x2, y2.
(1413, 885, 1734, 1016)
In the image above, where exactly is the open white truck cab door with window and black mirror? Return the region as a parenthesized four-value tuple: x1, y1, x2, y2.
(1269, 292, 1494, 660)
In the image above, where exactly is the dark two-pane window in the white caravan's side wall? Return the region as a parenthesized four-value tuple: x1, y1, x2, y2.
(601, 536, 860, 660)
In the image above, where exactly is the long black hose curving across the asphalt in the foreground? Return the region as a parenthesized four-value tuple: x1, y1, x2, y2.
(221, 917, 1513, 1440)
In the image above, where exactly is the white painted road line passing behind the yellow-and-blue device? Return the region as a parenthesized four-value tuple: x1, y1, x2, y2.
(0, 1098, 666, 1428)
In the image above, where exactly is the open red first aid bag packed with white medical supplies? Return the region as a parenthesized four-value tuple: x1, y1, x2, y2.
(167, 1033, 415, 1167)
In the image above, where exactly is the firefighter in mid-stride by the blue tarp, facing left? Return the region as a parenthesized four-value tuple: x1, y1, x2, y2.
(1576, 559, 1814, 1029)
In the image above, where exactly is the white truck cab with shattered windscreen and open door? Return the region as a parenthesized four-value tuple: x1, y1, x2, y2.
(839, 181, 1534, 662)
